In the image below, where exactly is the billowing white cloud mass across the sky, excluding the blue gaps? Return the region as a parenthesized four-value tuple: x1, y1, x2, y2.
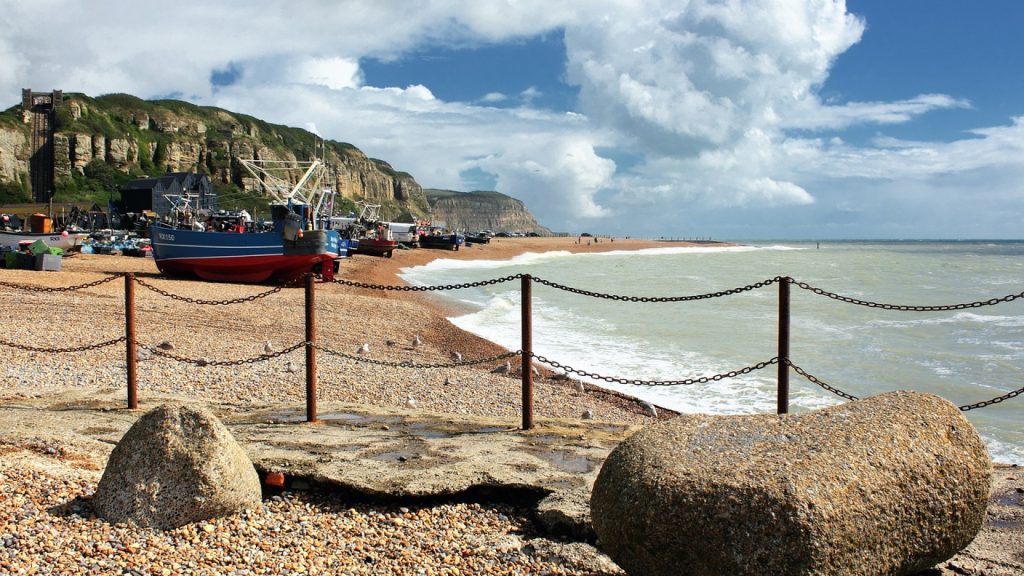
(0, 0, 1024, 236)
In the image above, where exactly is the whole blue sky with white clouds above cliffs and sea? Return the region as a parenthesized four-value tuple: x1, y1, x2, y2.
(0, 0, 1024, 240)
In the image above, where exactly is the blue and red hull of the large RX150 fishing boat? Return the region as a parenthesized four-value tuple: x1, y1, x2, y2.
(150, 224, 347, 283)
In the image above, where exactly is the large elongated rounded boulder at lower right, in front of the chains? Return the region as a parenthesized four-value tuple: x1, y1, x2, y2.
(591, 392, 991, 576)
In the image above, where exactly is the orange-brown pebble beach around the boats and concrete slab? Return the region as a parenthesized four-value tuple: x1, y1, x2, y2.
(0, 238, 658, 574)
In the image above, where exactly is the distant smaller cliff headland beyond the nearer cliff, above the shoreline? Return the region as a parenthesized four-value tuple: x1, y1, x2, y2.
(424, 189, 551, 236)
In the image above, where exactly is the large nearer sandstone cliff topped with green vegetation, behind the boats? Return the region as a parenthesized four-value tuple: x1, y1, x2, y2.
(0, 93, 429, 218)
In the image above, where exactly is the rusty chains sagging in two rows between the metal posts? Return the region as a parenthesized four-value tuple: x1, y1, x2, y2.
(0, 274, 1024, 412)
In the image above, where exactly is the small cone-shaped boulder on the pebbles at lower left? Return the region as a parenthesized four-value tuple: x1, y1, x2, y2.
(92, 405, 261, 529)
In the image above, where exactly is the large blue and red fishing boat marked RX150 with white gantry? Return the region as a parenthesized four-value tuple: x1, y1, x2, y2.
(150, 160, 348, 283)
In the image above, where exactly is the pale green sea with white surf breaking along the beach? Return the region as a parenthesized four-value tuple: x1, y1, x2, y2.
(401, 241, 1024, 464)
